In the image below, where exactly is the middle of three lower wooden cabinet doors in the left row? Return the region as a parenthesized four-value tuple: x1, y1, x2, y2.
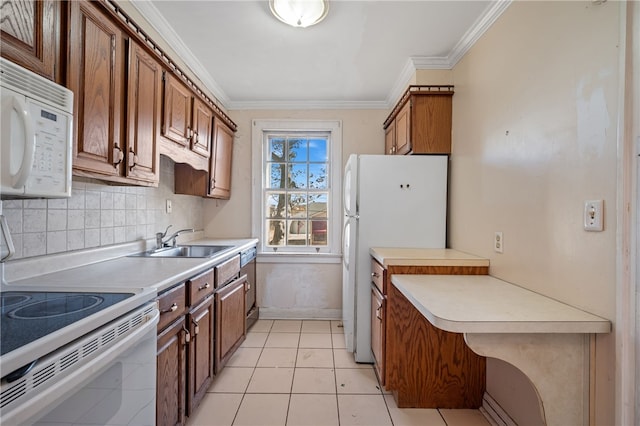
(187, 296, 214, 416)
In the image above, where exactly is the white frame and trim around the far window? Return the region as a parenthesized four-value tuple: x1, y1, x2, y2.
(251, 120, 342, 261)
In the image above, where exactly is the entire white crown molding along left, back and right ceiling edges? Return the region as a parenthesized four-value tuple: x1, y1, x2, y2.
(130, 0, 513, 110)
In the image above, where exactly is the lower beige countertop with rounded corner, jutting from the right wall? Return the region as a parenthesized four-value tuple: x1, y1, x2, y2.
(391, 275, 611, 333)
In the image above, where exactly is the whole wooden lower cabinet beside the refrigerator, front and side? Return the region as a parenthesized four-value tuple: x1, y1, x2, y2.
(371, 259, 489, 408)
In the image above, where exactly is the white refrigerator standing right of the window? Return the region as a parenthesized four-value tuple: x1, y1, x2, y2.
(342, 154, 448, 363)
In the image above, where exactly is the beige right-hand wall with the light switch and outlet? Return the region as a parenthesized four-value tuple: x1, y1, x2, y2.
(450, 1, 619, 425)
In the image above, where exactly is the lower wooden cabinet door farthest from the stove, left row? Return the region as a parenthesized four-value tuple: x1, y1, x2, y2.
(215, 275, 247, 374)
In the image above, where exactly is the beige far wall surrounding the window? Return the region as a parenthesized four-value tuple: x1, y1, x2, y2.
(204, 110, 388, 318)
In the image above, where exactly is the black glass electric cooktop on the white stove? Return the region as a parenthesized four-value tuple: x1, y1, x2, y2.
(0, 291, 134, 355)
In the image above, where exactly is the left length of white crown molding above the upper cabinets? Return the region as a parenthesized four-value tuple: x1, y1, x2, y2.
(129, 1, 230, 108)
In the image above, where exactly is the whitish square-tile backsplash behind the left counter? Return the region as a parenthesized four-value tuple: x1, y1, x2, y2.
(1, 156, 204, 259)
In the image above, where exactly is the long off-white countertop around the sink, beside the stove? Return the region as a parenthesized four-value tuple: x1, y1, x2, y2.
(2, 238, 258, 293)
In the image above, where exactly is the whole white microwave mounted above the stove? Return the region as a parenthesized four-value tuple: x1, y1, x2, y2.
(0, 58, 73, 199)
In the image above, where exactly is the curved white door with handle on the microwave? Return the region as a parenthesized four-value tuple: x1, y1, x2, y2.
(0, 88, 36, 195)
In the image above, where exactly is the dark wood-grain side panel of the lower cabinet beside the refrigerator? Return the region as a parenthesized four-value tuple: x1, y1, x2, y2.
(386, 284, 486, 408)
